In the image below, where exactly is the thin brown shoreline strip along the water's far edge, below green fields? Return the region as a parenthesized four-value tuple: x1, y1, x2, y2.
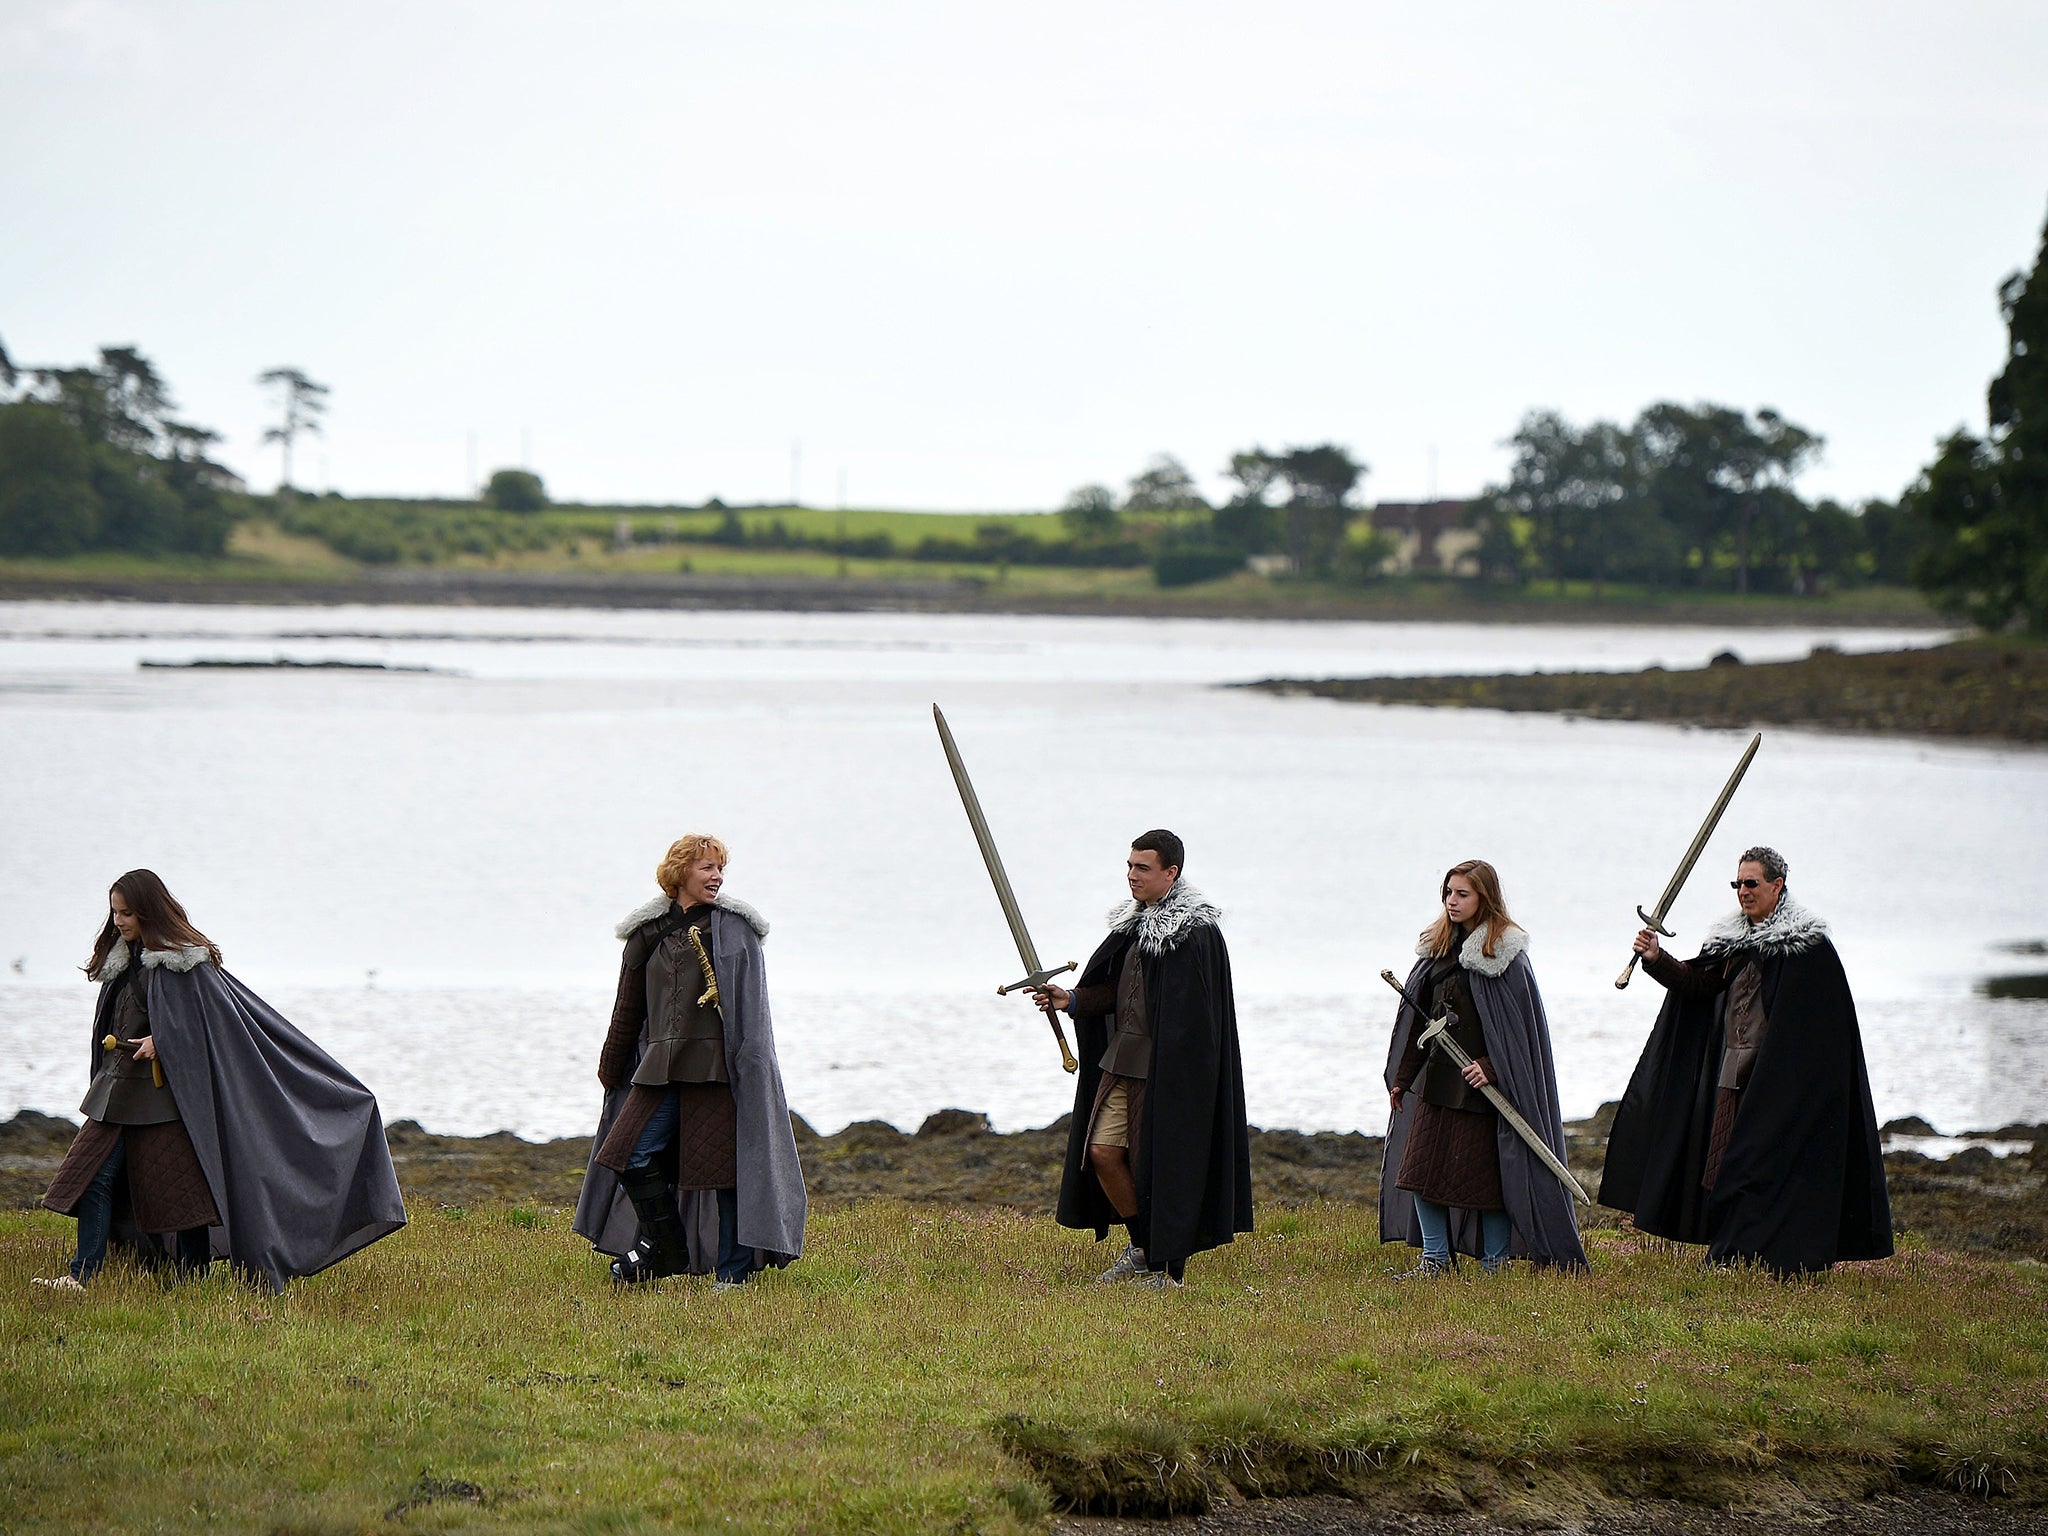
(0, 561, 1952, 629)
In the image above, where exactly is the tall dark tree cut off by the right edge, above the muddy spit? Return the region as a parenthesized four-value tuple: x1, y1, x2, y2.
(1905, 210, 2048, 635)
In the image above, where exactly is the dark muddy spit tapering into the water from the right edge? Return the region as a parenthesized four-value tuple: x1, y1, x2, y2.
(1245, 641, 2048, 741)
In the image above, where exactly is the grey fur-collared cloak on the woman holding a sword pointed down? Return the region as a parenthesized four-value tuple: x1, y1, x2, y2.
(1380, 928, 1587, 1270)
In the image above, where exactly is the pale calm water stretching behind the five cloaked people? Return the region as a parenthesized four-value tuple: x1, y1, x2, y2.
(0, 604, 2048, 1137)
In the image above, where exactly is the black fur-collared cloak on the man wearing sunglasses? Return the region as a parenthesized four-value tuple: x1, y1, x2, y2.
(1599, 895, 1892, 1274)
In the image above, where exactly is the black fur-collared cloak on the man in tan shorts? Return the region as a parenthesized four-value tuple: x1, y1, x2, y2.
(1059, 881, 1251, 1264)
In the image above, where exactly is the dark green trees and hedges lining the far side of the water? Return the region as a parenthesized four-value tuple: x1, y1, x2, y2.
(0, 207, 2048, 635)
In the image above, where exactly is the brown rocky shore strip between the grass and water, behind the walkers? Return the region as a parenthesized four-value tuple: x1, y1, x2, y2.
(0, 1104, 2048, 1262)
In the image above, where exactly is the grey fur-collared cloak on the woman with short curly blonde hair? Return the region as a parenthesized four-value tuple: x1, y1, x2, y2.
(573, 895, 809, 1274)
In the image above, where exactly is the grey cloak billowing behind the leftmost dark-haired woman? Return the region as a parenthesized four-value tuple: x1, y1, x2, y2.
(108, 946, 406, 1290)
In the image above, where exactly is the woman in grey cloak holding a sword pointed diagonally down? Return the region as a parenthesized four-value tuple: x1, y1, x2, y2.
(1380, 858, 1585, 1276)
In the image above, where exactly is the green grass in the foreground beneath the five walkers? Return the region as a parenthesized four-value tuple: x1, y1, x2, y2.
(0, 1202, 2048, 1532)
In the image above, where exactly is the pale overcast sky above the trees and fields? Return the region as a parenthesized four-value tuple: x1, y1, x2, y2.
(0, 0, 2048, 510)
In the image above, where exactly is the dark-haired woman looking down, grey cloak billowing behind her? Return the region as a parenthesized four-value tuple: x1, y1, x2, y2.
(37, 868, 406, 1290)
